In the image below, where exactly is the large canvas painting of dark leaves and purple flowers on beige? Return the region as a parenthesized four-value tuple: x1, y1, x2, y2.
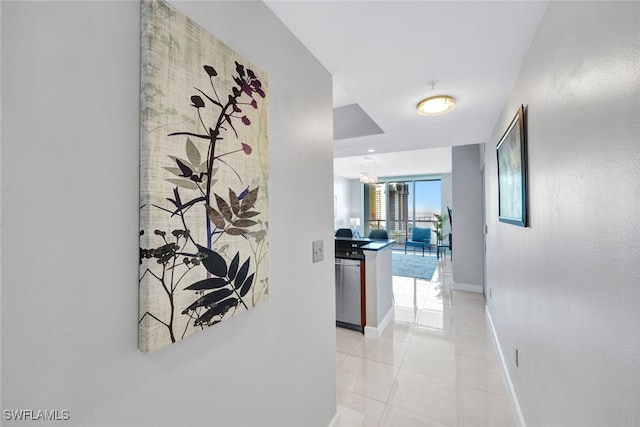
(138, 0, 269, 352)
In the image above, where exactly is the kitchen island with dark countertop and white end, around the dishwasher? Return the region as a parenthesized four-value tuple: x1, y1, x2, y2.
(336, 237, 395, 339)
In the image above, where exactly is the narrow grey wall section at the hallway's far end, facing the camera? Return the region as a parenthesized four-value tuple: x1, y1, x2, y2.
(451, 144, 484, 292)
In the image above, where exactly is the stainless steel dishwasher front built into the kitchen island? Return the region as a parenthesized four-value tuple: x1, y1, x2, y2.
(336, 258, 364, 332)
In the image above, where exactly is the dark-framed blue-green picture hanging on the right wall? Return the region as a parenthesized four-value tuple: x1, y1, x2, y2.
(496, 105, 528, 227)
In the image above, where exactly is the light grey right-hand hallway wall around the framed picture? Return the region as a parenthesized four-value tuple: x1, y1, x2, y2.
(484, 2, 640, 426)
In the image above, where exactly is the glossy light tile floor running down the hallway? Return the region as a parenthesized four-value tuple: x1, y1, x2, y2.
(336, 260, 515, 427)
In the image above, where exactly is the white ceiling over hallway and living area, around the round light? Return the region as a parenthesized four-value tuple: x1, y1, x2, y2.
(265, 0, 547, 178)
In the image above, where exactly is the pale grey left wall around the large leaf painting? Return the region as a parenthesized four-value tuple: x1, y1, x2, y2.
(1, 1, 336, 426)
